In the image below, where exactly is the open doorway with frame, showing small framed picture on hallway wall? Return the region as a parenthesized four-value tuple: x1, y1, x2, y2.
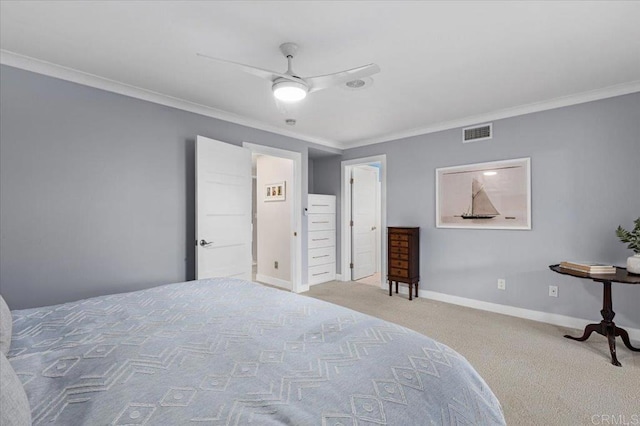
(243, 142, 304, 293)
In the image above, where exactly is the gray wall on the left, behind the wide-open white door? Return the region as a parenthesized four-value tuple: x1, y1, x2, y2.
(0, 66, 324, 309)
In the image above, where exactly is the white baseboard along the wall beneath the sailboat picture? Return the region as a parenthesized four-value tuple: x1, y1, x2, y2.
(390, 287, 640, 342)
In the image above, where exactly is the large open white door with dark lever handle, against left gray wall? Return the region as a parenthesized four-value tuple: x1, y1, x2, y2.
(196, 136, 252, 280)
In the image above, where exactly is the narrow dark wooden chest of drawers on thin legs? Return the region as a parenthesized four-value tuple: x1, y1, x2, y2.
(387, 227, 420, 300)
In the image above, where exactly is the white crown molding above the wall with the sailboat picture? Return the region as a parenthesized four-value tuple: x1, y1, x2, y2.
(342, 80, 640, 149)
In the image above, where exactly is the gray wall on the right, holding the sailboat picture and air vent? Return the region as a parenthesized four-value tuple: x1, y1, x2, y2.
(314, 93, 640, 328)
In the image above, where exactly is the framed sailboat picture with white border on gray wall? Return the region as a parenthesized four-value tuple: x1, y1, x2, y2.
(436, 158, 531, 229)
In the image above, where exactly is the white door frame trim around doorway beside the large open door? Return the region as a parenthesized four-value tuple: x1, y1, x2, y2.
(242, 142, 309, 293)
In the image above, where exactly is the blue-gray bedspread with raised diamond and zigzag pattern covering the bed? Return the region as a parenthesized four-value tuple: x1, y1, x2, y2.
(7, 278, 504, 425)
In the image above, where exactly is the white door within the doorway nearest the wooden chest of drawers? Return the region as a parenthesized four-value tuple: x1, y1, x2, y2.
(351, 166, 378, 281)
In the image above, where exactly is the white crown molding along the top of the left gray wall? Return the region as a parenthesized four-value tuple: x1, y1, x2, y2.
(0, 49, 342, 149)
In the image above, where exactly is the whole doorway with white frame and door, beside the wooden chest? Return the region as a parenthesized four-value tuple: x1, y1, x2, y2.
(341, 155, 387, 287)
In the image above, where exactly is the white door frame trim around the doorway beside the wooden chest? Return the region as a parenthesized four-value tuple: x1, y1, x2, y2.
(340, 154, 387, 288)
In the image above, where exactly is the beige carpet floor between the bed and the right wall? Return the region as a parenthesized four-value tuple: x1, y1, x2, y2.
(305, 281, 640, 426)
